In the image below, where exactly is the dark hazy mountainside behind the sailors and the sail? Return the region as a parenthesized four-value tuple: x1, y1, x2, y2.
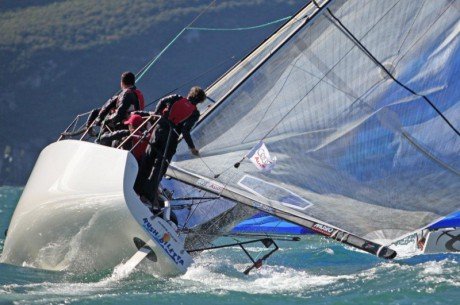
(0, 0, 306, 185)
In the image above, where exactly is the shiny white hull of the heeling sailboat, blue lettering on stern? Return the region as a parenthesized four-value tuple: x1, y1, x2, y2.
(1, 140, 192, 275)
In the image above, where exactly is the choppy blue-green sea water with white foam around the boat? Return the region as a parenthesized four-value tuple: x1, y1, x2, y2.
(0, 187, 460, 305)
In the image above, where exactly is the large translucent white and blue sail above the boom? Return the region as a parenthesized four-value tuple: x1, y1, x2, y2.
(169, 0, 460, 253)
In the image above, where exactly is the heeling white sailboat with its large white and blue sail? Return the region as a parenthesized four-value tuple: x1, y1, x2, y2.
(2, 0, 460, 275)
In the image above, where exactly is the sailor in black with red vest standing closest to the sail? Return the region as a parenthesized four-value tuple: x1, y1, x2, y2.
(134, 87, 206, 207)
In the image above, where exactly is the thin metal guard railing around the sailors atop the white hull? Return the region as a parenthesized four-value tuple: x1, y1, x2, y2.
(58, 111, 160, 156)
